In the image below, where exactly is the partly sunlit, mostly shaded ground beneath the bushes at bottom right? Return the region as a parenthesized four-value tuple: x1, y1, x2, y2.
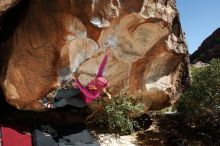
(92, 114, 220, 146)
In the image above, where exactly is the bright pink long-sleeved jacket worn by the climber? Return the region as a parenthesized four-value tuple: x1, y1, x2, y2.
(75, 55, 108, 104)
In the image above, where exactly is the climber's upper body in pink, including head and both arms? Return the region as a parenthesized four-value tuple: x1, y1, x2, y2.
(72, 47, 111, 104)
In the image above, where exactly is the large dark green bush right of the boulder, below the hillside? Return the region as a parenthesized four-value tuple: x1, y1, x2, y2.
(177, 59, 220, 126)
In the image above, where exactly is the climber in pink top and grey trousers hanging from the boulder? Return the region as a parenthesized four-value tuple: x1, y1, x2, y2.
(42, 47, 111, 108)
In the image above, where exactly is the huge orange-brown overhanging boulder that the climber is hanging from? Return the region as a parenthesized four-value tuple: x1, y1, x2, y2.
(0, 0, 189, 110)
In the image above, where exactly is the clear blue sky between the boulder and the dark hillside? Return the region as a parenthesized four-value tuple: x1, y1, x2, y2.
(176, 0, 220, 53)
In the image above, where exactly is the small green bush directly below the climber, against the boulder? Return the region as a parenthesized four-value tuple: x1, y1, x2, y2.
(96, 94, 144, 134)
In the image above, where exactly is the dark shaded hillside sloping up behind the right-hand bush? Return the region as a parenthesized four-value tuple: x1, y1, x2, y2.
(190, 28, 220, 63)
